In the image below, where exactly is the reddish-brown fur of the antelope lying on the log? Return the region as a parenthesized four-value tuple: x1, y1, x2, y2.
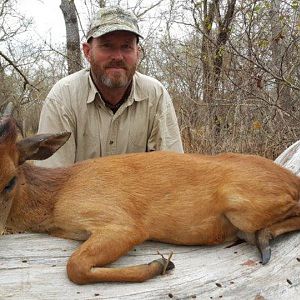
(0, 119, 300, 284)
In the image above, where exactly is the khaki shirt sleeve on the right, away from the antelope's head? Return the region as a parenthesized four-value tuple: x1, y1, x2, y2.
(147, 88, 183, 153)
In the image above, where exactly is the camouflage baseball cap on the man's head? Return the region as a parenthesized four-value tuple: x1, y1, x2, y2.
(87, 6, 142, 40)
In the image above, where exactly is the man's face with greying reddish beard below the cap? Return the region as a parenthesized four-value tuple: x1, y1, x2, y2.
(83, 31, 140, 88)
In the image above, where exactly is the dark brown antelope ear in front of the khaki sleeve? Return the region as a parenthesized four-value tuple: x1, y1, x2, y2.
(16, 132, 71, 165)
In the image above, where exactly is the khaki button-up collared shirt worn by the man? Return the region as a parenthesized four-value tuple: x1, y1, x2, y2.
(36, 69, 183, 167)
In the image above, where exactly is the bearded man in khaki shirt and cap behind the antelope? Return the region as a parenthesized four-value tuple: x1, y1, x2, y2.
(37, 7, 183, 167)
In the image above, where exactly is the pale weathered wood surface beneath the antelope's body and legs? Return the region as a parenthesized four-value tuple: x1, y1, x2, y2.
(0, 233, 300, 299)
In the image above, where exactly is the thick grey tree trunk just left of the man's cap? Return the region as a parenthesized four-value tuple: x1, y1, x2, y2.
(60, 0, 82, 74)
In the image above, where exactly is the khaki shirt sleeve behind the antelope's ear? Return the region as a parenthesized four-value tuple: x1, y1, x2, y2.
(35, 90, 76, 168)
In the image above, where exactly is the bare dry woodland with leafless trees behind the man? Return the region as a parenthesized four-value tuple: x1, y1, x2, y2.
(0, 0, 300, 159)
